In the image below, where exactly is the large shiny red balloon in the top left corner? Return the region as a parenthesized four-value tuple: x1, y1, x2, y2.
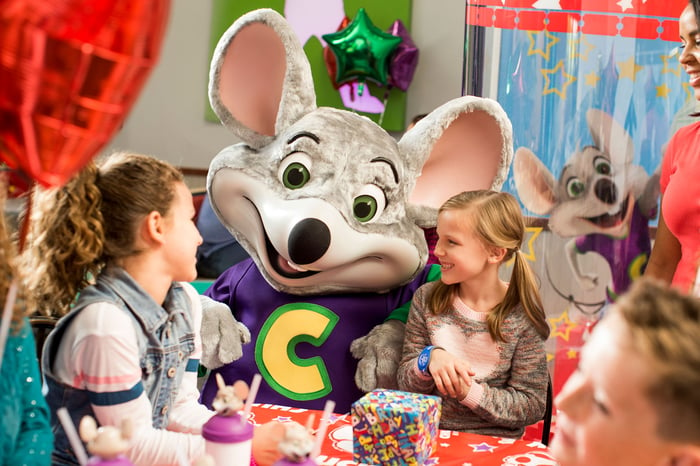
(0, 0, 170, 187)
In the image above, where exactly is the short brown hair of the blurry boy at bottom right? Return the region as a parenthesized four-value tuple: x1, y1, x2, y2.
(610, 277, 700, 445)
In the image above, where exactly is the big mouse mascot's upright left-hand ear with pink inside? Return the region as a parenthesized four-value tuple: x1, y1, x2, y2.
(209, 9, 316, 149)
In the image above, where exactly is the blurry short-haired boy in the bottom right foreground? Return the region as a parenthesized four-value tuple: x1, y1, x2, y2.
(551, 277, 700, 466)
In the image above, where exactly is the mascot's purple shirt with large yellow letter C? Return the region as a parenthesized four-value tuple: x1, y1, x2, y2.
(202, 259, 430, 413)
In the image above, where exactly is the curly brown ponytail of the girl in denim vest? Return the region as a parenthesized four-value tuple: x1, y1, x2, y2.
(22, 162, 104, 317)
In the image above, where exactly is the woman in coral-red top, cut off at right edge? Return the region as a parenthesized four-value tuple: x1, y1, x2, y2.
(644, 0, 700, 292)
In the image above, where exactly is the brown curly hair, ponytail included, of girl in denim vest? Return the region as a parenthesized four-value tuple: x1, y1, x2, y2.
(22, 152, 183, 317)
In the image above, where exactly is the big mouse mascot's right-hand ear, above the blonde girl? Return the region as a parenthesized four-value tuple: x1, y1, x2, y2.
(399, 96, 513, 215)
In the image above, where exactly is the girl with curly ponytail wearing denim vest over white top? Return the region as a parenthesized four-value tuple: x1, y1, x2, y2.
(23, 153, 219, 465)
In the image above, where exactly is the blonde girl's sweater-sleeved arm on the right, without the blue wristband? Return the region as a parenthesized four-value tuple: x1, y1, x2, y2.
(461, 318, 548, 428)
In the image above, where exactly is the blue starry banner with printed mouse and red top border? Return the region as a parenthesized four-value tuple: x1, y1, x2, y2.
(464, 0, 695, 426)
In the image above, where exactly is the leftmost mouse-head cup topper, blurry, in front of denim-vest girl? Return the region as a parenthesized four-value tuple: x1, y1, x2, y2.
(79, 416, 133, 466)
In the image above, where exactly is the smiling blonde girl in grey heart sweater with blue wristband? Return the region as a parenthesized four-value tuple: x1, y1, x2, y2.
(398, 190, 549, 438)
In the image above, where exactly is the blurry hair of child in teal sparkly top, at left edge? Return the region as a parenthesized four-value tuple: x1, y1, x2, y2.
(0, 176, 27, 331)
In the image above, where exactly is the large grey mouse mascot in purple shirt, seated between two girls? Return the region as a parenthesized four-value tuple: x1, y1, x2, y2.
(202, 9, 513, 412)
